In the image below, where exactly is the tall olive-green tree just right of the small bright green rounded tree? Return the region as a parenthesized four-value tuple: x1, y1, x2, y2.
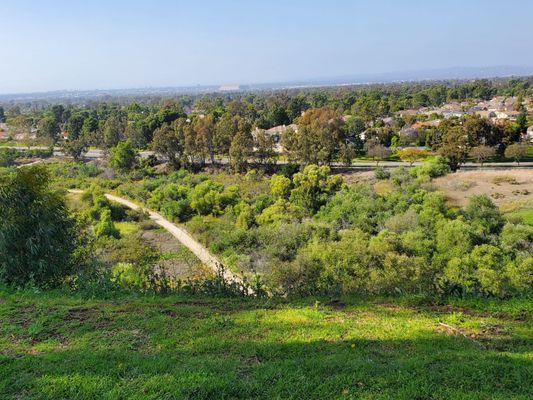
(152, 118, 187, 169)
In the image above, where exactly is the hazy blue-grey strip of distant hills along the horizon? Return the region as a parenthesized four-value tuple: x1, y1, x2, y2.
(0, 66, 533, 102)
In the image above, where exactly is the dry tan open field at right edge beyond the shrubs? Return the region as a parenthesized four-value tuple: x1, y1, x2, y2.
(433, 169, 533, 206)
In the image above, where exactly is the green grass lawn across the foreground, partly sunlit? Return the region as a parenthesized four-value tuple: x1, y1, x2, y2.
(0, 291, 533, 400)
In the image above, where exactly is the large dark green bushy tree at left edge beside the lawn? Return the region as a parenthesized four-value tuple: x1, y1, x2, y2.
(0, 166, 83, 287)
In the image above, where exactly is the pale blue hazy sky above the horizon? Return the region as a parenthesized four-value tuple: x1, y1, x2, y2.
(0, 0, 533, 93)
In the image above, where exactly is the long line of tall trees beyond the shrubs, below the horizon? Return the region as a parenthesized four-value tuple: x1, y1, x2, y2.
(1, 79, 531, 171)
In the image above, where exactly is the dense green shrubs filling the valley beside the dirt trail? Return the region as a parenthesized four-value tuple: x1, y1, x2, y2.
(1, 158, 533, 297)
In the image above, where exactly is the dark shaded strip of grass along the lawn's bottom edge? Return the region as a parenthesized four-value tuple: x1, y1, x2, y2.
(0, 333, 533, 399)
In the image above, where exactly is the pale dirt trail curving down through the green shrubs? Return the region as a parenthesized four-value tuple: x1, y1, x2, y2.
(69, 189, 243, 284)
